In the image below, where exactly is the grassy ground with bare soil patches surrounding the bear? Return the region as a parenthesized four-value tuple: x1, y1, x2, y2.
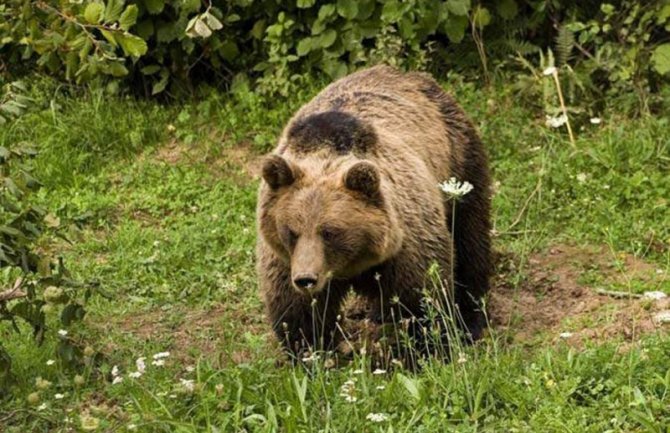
(0, 76, 670, 432)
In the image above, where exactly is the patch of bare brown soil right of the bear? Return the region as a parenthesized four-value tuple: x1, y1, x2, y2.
(489, 245, 670, 346)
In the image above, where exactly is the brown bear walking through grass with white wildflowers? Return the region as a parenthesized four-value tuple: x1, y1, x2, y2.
(257, 66, 492, 353)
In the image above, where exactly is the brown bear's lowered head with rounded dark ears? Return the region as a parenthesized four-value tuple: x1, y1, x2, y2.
(259, 155, 402, 294)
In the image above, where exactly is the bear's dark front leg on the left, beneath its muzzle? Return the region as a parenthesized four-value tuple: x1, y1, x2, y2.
(265, 276, 344, 355)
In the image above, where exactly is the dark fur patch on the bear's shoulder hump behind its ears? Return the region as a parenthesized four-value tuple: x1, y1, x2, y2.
(288, 111, 377, 155)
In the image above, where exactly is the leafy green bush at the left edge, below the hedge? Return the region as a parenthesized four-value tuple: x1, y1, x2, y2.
(0, 138, 97, 394)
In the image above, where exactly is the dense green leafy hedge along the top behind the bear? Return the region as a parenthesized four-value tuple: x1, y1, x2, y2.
(0, 0, 670, 99)
